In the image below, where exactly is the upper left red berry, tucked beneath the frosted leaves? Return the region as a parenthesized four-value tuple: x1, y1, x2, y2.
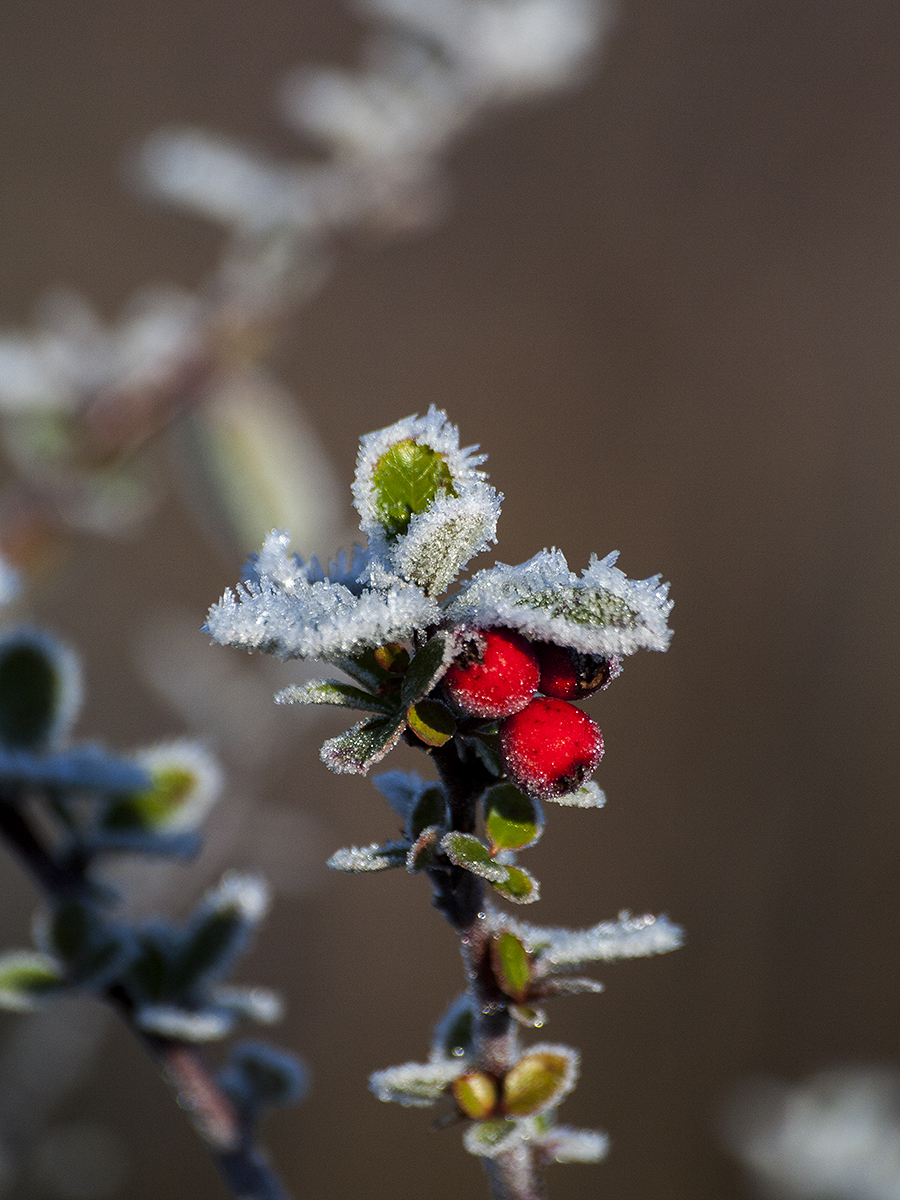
(444, 629, 540, 719)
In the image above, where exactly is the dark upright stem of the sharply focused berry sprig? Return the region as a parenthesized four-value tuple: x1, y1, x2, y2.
(428, 740, 545, 1200)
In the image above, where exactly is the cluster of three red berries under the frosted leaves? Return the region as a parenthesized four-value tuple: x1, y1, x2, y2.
(444, 629, 618, 799)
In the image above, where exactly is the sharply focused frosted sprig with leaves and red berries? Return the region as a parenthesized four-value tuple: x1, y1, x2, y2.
(205, 408, 682, 1180)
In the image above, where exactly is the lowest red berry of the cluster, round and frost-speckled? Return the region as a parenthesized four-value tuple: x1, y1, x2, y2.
(500, 696, 604, 799)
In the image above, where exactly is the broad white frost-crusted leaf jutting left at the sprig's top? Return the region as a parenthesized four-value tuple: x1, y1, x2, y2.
(204, 532, 438, 659)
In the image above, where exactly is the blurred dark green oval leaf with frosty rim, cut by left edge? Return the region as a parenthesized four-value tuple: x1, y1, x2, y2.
(0, 630, 80, 750)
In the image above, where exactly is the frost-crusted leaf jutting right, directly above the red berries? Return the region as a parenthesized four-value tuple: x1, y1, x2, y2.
(446, 550, 672, 658)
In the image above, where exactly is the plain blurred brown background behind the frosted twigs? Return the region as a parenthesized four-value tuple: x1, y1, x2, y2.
(0, 0, 900, 1200)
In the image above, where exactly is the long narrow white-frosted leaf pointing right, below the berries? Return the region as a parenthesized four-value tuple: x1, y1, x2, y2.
(506, 912, 684, 972)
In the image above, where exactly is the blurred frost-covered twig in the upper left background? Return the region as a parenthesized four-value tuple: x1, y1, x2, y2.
(0, 0, 612, 566)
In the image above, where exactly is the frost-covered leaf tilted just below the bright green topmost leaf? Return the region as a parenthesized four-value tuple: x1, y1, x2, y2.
(390, 482, 500, 595)
